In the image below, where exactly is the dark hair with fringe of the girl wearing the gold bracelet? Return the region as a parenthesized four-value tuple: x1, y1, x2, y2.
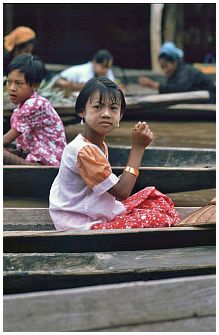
(75, 77, 126, 114)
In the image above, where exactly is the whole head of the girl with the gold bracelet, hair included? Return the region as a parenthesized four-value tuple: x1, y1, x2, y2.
(75, 77, 126, 135)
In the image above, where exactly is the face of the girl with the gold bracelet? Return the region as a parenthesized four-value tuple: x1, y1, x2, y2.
(80, 92, 122, 135)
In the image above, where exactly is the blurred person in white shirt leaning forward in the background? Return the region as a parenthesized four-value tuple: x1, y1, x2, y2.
(54, 49, 115, 92)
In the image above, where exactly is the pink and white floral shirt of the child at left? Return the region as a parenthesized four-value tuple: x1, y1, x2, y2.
(11, 92, 66, 166)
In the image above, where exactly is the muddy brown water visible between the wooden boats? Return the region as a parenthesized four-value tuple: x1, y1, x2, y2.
(4, 121, 216, 208)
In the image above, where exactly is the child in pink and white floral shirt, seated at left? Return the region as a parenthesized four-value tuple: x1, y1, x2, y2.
(3, 55, 66, 166)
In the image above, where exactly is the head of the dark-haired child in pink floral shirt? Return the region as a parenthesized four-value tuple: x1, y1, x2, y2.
(7, 55, 46, 104)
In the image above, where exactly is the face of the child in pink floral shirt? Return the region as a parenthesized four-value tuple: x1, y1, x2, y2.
(7, 70, 34, 104)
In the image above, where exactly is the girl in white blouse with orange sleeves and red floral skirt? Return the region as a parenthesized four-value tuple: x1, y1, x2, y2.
(50, 78, 179, 230)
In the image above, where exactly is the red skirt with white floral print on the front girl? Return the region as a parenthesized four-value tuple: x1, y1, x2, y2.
(90, 186, 180, 230)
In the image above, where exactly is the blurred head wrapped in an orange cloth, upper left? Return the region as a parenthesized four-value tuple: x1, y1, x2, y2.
(4, 26, 36, 56)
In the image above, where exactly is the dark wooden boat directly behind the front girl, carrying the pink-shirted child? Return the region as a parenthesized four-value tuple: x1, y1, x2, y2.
(3, 146, 216, 198)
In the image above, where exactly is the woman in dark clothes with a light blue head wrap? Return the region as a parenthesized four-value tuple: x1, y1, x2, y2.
(139, 42, 216, 103)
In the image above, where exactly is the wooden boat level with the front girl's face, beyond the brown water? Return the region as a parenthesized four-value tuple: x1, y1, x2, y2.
(4, 91, 216, 125)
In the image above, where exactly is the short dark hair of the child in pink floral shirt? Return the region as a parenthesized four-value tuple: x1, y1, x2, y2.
(6, 55, 46, 85)
